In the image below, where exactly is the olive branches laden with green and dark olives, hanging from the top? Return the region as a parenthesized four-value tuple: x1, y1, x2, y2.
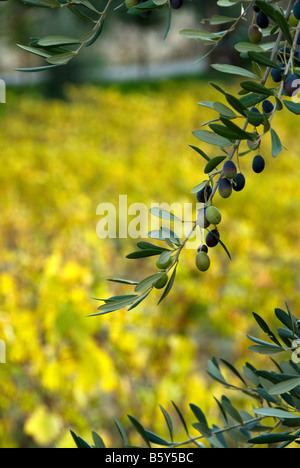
(15, 0, 300, 315)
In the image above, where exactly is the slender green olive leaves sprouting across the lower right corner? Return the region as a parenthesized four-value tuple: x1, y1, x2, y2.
(71, 305, 300, 448)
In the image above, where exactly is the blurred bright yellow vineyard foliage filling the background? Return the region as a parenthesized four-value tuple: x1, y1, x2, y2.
(0, 81, 300, 447)
